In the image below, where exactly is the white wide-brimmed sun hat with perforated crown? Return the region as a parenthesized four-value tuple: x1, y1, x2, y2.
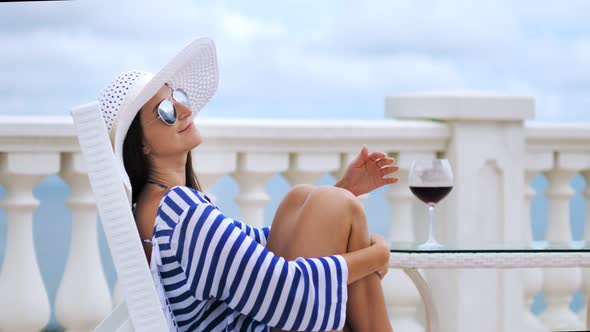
(98, 38, 219, 200)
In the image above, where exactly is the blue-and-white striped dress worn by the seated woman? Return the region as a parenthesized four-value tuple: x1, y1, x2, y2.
(150, 187, 348, 332)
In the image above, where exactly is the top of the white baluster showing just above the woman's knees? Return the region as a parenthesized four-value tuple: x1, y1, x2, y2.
(283, 153, 340, 186)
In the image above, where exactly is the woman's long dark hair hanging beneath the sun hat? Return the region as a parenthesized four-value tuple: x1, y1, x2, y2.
(123, 112, 201, 205)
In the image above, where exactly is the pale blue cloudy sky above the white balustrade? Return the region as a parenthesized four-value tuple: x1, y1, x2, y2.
(0, 0, 590, 122)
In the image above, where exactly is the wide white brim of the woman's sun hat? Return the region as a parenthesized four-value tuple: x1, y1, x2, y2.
(113, 38, 219, 197)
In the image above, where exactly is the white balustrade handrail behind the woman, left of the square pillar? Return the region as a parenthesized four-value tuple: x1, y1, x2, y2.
(0, 116, 450, 152)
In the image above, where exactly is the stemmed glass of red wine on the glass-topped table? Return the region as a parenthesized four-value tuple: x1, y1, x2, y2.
(408, 159, 453, 249)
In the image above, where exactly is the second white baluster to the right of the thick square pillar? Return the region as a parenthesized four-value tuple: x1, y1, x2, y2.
(540, 166, 583, 330)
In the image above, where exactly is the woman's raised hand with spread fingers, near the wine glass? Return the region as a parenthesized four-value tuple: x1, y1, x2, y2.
(336, 145, 399, 196)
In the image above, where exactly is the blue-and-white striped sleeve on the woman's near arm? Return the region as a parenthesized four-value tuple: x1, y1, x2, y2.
(171, 191, 348, 331)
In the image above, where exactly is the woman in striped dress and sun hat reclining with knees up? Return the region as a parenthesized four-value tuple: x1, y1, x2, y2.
(99, 39, 397, 331)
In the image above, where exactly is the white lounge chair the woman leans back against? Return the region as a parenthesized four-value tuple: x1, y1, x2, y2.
(72, 102, 168, 332)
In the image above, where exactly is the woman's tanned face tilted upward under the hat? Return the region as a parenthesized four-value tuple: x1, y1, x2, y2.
(140, 85, 202, 156)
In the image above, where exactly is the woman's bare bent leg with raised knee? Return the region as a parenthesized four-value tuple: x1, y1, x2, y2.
(267, 186, 391, 332)
